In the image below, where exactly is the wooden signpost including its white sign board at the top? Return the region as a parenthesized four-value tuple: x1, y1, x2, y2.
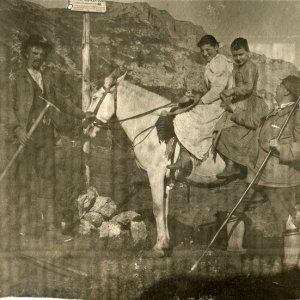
(68, 0, 106, 187)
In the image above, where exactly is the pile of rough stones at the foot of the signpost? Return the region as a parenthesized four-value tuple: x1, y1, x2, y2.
(77, 187, 148, 246)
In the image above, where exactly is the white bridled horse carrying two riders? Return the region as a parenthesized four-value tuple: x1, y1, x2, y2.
(85, 78, 224, 255)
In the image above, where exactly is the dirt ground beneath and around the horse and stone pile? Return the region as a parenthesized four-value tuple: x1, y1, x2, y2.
(0, 131, 299, 299)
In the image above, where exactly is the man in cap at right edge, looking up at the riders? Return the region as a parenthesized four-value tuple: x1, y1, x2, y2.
(248, 75, 300, 238)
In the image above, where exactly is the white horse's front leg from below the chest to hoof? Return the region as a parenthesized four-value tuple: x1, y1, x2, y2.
(147, 167, 169, 254)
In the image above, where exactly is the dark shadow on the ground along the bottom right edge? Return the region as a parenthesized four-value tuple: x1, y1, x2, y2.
(137, 269, 300, 300)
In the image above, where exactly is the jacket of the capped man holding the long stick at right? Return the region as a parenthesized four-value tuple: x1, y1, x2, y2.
(248, 106, 300, 188)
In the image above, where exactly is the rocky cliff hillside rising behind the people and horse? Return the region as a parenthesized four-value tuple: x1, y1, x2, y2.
(0, 0, 298, 116)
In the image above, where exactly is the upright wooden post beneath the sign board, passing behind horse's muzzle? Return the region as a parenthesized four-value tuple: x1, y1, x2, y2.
(82, 13, 91, 188)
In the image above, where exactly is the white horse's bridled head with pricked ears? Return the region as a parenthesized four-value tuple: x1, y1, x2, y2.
(84, 69, 126, 137)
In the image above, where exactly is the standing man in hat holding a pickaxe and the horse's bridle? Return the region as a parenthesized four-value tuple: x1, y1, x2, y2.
(5, 35, 94, 241)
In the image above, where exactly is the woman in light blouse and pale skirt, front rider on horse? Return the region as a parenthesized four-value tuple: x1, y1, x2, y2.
(168, 35, 233, 173)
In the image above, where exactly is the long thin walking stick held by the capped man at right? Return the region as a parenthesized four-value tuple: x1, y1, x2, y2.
(190, 97, 300, 272)
